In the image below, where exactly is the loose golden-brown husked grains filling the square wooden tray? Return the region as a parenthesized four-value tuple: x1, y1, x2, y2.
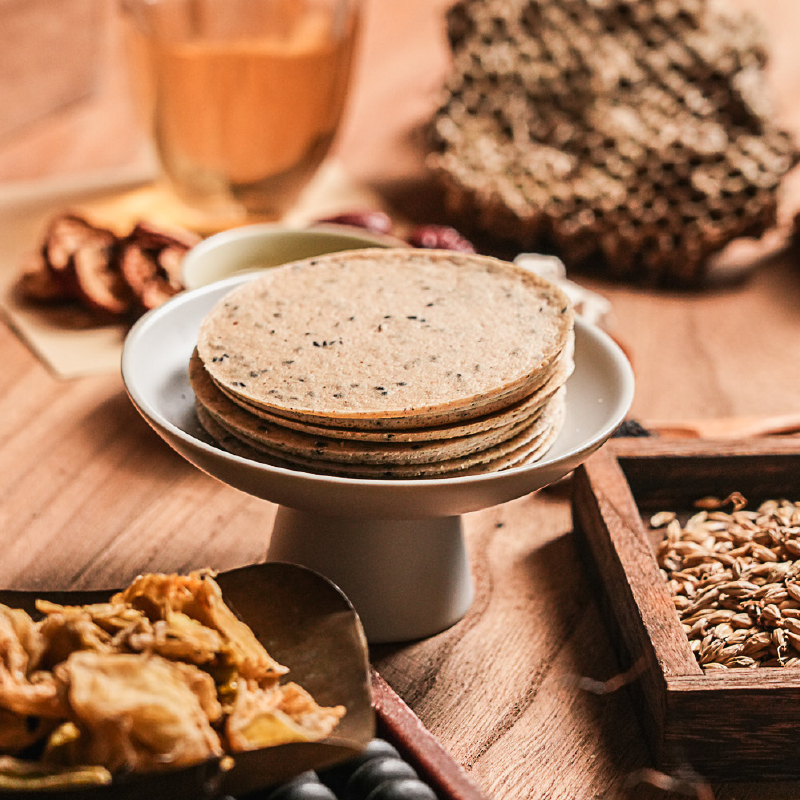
(650, 493, 800, 672)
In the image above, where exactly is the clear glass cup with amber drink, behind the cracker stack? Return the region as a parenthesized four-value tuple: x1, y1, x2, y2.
(122, 0, 358, 218)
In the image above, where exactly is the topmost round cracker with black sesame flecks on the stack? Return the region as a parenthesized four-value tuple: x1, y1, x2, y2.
(198, 249, 573, 429)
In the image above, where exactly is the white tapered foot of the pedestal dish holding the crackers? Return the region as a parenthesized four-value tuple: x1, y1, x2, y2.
(267, 506, 473, 644)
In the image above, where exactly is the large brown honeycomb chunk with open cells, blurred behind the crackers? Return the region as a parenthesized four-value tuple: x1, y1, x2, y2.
(430, 0, 798, 285)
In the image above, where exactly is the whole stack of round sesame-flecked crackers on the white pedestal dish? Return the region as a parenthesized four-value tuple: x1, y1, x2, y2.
(189, 248, 573, 478)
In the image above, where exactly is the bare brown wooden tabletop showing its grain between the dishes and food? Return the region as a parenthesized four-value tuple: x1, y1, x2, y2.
(0, 0, 800, 800)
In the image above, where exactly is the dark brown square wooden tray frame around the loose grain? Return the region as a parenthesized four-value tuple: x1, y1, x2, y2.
(573, 438, 800, 781)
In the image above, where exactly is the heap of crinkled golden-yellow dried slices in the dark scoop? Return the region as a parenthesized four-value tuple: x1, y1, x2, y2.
(0, 570, 345, 791)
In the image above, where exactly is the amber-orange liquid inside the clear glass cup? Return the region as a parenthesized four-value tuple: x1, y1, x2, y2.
(130, 4, 357, 215)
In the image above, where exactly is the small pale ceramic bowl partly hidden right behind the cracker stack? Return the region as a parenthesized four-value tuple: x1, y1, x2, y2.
(181, 222, 408, 289)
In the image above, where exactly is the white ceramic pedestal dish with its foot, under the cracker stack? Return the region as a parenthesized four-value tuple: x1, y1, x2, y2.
(122, 275, 633, 642)
